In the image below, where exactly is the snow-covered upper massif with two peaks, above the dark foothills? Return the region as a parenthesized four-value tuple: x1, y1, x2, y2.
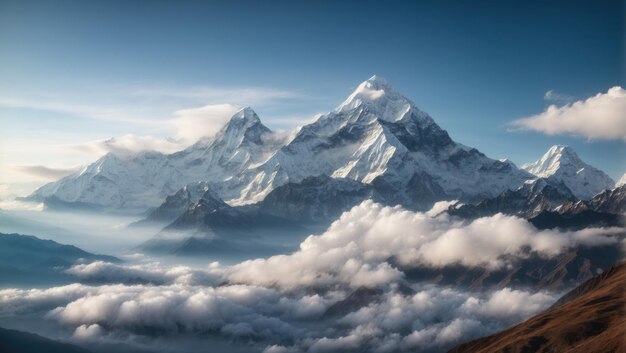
(31, 76, 588, 210)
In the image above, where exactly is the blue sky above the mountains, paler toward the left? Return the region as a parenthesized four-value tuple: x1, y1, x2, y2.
(0, 0, 626, 192)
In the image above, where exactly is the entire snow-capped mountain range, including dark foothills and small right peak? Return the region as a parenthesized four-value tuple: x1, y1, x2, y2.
(20, 76, 624, 253)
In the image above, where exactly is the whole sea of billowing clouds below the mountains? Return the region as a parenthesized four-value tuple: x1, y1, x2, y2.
(0, 201, 623, 353)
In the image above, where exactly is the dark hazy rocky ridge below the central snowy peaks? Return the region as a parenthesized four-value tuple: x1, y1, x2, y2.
(139, 176, 382, 254)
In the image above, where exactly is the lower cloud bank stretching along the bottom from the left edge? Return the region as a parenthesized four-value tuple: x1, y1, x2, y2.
(0, 284, 556, 353)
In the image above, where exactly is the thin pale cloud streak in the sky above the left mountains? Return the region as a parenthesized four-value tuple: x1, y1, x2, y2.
(0, 84, 305, 127)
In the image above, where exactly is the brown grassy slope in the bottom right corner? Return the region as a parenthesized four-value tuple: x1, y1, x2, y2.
(449, 263, 626, 353)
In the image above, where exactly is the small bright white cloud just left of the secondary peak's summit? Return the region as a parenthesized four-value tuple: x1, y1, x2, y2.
(169, 104, 240, 143)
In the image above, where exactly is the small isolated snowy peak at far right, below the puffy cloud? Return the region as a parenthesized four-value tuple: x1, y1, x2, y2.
(522, 145, 615, 199)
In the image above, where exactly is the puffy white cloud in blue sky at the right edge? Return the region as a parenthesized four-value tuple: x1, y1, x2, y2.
(511, 87, 626, 141)
